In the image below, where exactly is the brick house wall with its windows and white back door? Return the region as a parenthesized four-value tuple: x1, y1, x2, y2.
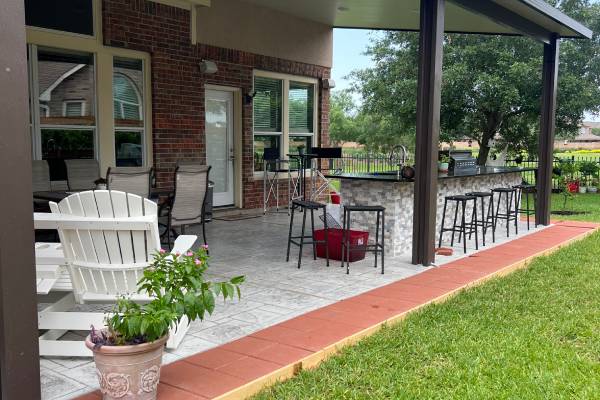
(25, 0, 333, 208)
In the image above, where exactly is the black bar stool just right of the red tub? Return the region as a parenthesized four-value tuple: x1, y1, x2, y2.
(341, 205, 385, 274)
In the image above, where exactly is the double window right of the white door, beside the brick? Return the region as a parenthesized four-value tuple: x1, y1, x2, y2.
(253, 71, 317, 171)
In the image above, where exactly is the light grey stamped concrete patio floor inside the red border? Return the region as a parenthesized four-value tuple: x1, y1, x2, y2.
(40, 213, 539, 400)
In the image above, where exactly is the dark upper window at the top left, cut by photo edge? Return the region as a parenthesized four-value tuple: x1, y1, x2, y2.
(25, 0, 94, 36)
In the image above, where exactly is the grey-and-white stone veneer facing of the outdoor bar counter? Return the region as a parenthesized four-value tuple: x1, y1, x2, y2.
(340, 172, 521, 256)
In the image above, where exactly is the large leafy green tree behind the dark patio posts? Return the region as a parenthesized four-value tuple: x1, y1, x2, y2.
(352, 0, 600, 164)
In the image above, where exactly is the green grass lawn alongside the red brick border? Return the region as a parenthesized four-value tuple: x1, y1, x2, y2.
(256, 200, 600, 399)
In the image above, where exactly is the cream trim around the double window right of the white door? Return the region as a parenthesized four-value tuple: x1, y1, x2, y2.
(252, 70, 320, 179)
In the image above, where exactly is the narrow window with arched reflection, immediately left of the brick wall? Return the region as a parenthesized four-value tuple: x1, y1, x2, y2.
(112, 58, 144, 167)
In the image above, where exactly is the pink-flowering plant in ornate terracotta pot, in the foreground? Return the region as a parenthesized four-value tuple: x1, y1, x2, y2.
(85, 247, 244, 400)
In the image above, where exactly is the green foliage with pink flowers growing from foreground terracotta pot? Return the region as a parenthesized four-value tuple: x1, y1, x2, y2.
(90, 247, 244, 346)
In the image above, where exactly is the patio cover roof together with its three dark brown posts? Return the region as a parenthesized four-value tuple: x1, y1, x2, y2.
(0, 0, 592, 399)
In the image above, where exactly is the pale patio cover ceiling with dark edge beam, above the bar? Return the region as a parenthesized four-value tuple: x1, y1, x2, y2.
(238, 0, 592, 42)
